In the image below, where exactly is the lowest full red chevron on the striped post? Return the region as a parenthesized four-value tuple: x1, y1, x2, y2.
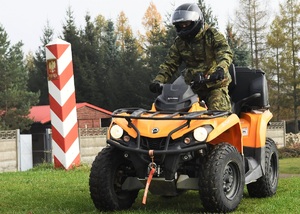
(52, 123, 78, 153)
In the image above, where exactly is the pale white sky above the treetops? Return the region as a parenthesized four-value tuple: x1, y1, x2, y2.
(0, 0, 280, 54)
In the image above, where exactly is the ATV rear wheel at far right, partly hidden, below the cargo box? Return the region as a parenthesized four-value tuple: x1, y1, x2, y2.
(247, 138, 278, 198)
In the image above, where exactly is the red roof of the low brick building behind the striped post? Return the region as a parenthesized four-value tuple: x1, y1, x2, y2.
(29, 103, 112, 124)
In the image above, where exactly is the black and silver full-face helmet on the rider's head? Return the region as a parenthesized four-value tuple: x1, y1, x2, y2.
(172, 3, 203, 39)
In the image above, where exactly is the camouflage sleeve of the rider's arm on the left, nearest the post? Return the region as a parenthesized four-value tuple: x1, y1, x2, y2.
(153, 43, 182, 83)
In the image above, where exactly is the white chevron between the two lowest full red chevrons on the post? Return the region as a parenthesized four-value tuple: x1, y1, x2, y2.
(50, 106, 77, 137)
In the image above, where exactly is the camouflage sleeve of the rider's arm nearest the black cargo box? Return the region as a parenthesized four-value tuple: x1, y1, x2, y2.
(211, 28, 233, 71)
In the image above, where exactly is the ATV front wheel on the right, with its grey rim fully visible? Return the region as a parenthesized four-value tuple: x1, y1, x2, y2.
(199, 143, 245, 212)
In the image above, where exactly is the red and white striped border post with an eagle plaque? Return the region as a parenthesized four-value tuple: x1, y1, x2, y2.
(46, 39, 80, 169)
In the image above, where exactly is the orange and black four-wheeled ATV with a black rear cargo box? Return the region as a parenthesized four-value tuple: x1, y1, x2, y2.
(89, 66, 278, 212)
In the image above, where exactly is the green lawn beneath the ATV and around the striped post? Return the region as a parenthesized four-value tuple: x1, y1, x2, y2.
(0, 158, 300, 214)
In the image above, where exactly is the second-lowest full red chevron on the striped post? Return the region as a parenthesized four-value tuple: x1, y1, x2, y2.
(49, 91, 76, 121)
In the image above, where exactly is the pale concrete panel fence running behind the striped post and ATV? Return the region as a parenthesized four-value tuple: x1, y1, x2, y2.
(0, 122, 286, 173)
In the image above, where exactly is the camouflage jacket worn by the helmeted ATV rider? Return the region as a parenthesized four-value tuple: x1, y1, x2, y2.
(153, 25, 232, 88)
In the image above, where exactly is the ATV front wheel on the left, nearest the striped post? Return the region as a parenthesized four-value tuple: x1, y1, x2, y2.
(89, 147, 139, 211)
